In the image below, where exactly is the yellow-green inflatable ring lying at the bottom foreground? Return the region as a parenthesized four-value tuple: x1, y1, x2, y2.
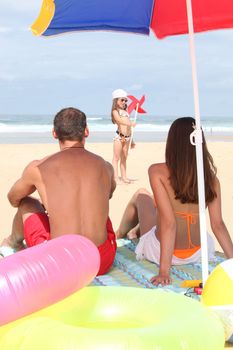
(0, 287, 224, 350)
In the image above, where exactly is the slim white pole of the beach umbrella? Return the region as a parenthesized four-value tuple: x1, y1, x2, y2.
(186, 0, 208, 285)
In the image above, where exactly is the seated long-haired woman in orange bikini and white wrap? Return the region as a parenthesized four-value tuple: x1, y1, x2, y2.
(116, 117, 233, 285)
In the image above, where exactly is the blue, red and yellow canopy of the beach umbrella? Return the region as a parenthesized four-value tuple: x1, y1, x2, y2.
(31, 0, 233, 38)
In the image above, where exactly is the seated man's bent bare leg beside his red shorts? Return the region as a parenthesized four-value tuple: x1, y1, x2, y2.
(1, 197, 45, 250)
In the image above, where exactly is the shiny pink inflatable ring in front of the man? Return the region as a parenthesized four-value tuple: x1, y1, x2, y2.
(0, 234, 100, 325)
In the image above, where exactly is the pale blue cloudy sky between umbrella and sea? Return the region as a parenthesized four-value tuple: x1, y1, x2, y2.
(0, 0, 233, 118)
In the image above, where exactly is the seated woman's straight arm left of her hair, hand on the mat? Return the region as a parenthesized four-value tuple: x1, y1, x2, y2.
(149, 164, 176, 286)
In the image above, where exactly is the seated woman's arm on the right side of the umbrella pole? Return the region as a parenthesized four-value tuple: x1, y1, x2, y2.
(208, 179, 233, 258)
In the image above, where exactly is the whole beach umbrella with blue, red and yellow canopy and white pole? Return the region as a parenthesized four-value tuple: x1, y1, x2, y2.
(31, 0, 233, 283)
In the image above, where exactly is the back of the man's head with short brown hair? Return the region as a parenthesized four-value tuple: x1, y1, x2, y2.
(53, 107, 87, 142)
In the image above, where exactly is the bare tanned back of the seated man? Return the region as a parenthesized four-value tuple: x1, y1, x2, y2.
(33, 147, 112, 246)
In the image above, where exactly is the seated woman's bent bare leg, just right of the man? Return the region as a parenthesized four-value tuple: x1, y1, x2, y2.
(116, 189, 156, 238)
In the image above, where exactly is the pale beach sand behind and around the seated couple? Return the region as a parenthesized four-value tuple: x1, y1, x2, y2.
(0, 142, 233, 250)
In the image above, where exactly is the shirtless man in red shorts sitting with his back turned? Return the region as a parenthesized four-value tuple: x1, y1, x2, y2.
(2, 108, 116, 274)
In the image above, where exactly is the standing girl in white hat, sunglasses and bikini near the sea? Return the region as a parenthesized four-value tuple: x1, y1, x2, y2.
(111, 89, 136, 184)
